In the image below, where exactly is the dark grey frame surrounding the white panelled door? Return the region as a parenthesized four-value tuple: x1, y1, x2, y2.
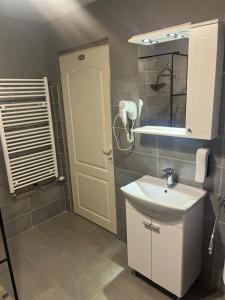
(57, 38, 117, 234)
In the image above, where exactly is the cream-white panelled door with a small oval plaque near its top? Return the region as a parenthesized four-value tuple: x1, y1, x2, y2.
(59, 45, 116, 233)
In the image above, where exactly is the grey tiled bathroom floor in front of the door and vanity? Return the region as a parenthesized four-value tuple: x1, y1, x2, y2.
(0, 213, 223, 300)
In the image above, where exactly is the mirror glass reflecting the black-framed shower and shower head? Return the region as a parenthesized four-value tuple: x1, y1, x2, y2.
(138, 39, 188, 128)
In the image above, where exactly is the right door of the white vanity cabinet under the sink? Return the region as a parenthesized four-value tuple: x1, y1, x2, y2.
(152, 219, 183, 295)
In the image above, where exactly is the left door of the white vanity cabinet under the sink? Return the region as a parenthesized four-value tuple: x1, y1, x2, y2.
(126, 201, 152, 279)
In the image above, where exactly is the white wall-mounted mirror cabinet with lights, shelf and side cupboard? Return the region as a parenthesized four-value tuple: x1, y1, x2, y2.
(129, 20, 224, 140)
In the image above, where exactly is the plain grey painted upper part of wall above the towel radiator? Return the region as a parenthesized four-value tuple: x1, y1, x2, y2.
(0, 16, 53, 78)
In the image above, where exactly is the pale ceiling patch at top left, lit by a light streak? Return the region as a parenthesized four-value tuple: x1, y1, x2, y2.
(0, 0, 96, 22)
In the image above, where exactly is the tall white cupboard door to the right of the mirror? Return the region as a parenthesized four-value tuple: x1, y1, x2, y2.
(186, 23, 224, 139)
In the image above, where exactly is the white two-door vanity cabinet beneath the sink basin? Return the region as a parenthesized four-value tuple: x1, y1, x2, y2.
(126, 200, 203, 297)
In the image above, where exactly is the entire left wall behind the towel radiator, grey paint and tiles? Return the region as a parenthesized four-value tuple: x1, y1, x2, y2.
(0, 16, 65, 237)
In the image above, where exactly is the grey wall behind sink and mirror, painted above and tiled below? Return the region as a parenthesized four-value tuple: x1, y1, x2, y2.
(48, 0, 225, 289)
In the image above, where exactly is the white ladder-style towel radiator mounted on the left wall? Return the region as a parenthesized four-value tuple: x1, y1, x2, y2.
(0, 77, 58, 194)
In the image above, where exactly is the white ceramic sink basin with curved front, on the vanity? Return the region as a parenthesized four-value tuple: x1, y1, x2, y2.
(121, 176, 206, 215)
